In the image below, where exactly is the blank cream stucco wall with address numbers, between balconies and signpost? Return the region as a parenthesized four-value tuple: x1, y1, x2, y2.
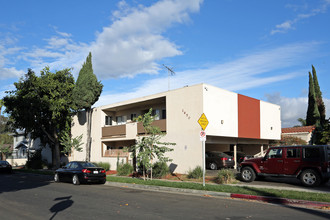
(164, 84, 203, 173)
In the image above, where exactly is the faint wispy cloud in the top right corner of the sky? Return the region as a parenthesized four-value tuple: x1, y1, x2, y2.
(270, 0, 330, 35)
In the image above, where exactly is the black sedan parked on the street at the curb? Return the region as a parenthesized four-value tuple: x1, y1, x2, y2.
(54, 161, 106, 185)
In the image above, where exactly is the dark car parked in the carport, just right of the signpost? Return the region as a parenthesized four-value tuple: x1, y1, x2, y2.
(205, 151, 235, 170)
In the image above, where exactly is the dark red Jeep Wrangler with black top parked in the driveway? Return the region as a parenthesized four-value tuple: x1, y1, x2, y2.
(240, 145, 330, 186)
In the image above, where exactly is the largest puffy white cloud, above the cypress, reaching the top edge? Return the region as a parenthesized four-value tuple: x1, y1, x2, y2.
(91, 0, 202, 79)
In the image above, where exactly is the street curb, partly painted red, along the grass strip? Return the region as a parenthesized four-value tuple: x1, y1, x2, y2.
(105, 181, 330, 209)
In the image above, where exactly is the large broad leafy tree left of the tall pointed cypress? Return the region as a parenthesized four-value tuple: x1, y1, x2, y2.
(3, 67, 74, 168)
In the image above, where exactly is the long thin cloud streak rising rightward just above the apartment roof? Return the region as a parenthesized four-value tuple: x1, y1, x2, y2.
(96, 42, 318, 106)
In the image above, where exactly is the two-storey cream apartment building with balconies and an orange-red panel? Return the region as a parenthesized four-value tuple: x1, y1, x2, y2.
(69, 84, 281, 173)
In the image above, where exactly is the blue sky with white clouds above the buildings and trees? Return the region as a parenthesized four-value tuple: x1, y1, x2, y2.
(0, 0, 330, 127)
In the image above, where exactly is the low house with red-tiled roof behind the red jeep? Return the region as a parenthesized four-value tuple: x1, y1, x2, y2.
(282, 126, 315, 144)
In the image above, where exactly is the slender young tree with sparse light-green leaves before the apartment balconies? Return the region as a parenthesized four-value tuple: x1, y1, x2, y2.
(131, 109, 175, 180)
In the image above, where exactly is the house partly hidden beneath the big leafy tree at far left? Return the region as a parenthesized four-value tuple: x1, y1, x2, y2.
(7, 132, 52, 166)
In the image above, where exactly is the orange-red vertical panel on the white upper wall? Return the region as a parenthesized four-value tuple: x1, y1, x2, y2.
(237, 94, 260, 139)
